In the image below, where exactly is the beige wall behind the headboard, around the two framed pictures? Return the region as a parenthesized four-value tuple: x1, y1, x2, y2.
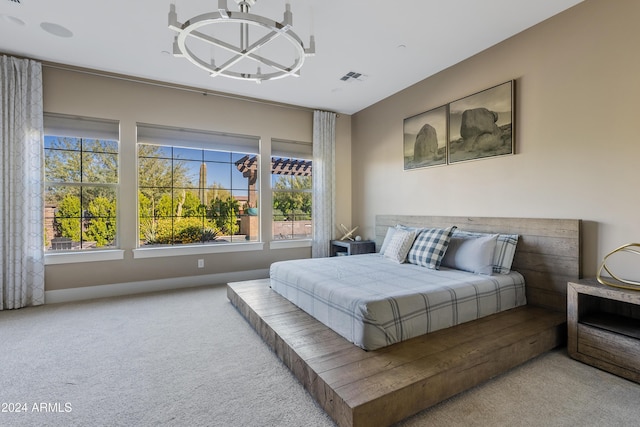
(352, 0, 640, 280)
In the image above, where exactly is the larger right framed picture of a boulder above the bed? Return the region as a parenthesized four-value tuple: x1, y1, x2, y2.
(447, 80, 514, 163)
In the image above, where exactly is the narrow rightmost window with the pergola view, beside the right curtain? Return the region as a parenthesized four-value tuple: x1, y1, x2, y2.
(271, 140, 313, 240)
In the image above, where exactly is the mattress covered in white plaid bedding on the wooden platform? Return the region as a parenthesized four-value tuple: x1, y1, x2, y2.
(270, 254, 526, 350)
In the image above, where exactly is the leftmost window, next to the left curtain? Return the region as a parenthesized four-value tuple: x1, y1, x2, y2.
(44, 114, 119, 251)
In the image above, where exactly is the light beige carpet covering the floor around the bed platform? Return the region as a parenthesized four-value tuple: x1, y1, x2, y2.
(0, 286, 640, 426)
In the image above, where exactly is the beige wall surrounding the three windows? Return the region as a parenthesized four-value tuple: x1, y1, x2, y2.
(43, 66, 351, 291)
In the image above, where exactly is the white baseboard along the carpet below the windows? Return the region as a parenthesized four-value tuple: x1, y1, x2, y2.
(45, 269, 269, 304)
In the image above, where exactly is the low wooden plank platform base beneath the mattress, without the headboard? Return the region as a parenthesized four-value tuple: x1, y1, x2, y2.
(227, 279, 566, 427)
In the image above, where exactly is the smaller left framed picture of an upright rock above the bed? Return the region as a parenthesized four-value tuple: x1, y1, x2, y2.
(403, 105, 447, 170)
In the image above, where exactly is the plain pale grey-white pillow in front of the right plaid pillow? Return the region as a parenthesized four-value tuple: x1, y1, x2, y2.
(442, 234, 498, 276)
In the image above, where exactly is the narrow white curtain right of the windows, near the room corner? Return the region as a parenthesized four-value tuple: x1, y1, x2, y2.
(311, 111, 336, 258)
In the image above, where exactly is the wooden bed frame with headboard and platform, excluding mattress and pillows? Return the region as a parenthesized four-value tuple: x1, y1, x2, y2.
(227, 215, 581, 426)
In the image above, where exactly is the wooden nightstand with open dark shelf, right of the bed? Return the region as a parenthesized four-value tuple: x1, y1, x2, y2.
(567, 279, 640, 383)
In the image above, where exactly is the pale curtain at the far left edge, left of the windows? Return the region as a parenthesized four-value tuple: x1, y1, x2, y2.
(0, 56, 44, 310)
